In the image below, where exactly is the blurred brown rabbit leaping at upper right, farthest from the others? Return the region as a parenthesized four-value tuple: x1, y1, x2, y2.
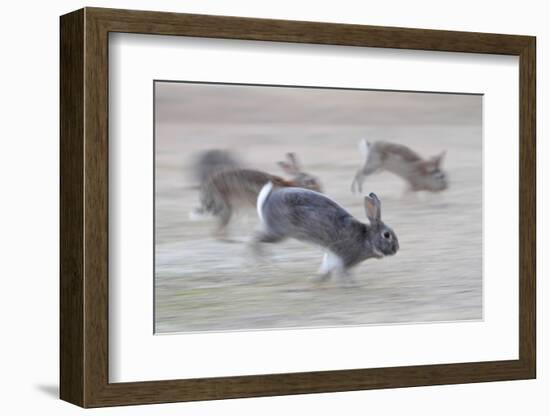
(351, 140, 448, 192)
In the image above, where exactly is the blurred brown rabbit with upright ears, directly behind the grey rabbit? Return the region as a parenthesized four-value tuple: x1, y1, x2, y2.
(195, 153, 321, 236)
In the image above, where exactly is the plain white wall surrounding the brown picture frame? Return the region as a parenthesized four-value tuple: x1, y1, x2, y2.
(0, 0, 550, 416)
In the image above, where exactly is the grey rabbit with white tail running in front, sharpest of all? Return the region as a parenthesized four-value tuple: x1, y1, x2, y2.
(253, 183, 399, 284)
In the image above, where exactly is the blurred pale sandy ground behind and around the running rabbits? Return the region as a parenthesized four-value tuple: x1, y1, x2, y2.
(154, 82, 483, 333)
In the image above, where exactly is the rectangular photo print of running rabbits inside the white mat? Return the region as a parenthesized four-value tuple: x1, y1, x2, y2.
(154, 80, 483, 334)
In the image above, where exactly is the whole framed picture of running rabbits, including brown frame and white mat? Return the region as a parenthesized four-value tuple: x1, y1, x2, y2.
(60, 8, 536, 407)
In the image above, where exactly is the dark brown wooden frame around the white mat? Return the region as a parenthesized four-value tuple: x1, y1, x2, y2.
(60, 8, 536, 407)
